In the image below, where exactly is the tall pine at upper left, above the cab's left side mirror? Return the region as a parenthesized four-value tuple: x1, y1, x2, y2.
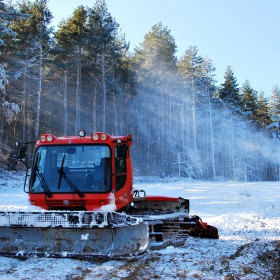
(6, 0, 52, 141)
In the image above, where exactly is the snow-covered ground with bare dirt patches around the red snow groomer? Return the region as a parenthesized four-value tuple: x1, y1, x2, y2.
(0, 170, 280, 280)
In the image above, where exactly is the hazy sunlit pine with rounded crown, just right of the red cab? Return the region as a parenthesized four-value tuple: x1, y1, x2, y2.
(132, 22, 178, 174)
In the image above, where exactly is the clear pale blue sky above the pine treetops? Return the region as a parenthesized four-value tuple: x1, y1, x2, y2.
(37, 0, 280, 96)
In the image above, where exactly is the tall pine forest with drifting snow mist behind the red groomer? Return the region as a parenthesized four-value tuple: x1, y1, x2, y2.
(0, 0, 280, 181)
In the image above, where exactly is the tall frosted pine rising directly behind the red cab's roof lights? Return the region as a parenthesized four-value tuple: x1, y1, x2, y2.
(87, 0, 129, 132)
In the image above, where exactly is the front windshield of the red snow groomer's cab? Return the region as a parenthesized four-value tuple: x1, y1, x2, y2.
(29, 145, 112, 194)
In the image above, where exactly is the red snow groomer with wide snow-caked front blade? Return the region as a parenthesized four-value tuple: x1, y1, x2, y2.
(0, 130, 219, 258)
